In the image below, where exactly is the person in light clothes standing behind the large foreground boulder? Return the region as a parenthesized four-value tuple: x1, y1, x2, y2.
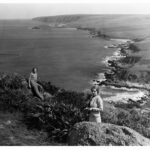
(87, 86, 103, 123)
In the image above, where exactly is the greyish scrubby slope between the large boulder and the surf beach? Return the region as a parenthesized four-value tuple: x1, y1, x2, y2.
(102, 108, 150, 138)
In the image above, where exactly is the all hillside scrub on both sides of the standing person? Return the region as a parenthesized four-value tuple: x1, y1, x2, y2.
(0, 74, 150, 143)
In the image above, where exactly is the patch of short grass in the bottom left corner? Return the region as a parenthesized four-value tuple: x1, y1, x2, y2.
(0, 111, 49, 146)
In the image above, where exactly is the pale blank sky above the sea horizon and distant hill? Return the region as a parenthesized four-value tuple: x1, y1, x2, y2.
(0, 0, 150, 19)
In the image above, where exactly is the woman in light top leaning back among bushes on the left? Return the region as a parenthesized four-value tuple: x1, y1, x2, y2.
(29, 68, 44, 100)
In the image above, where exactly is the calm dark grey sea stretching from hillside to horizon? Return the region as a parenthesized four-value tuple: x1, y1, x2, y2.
(0, 21, 115, 91)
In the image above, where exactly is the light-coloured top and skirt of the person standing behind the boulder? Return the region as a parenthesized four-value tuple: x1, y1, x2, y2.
(89, 95, 103, 123)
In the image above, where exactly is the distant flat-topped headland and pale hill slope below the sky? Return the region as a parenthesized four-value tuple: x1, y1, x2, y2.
(33, 14, 150, 38)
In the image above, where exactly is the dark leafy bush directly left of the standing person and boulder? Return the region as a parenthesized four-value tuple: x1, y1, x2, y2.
(24, 90, 88, 142)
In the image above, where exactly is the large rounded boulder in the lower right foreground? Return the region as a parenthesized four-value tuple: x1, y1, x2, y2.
(68, 122, 150, 146)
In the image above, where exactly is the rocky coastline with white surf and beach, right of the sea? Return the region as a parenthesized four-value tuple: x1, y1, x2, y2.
(88, 34, 150, 106)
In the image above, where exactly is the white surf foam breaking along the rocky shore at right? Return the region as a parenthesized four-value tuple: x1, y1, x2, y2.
(90, 39, 150, 103)
